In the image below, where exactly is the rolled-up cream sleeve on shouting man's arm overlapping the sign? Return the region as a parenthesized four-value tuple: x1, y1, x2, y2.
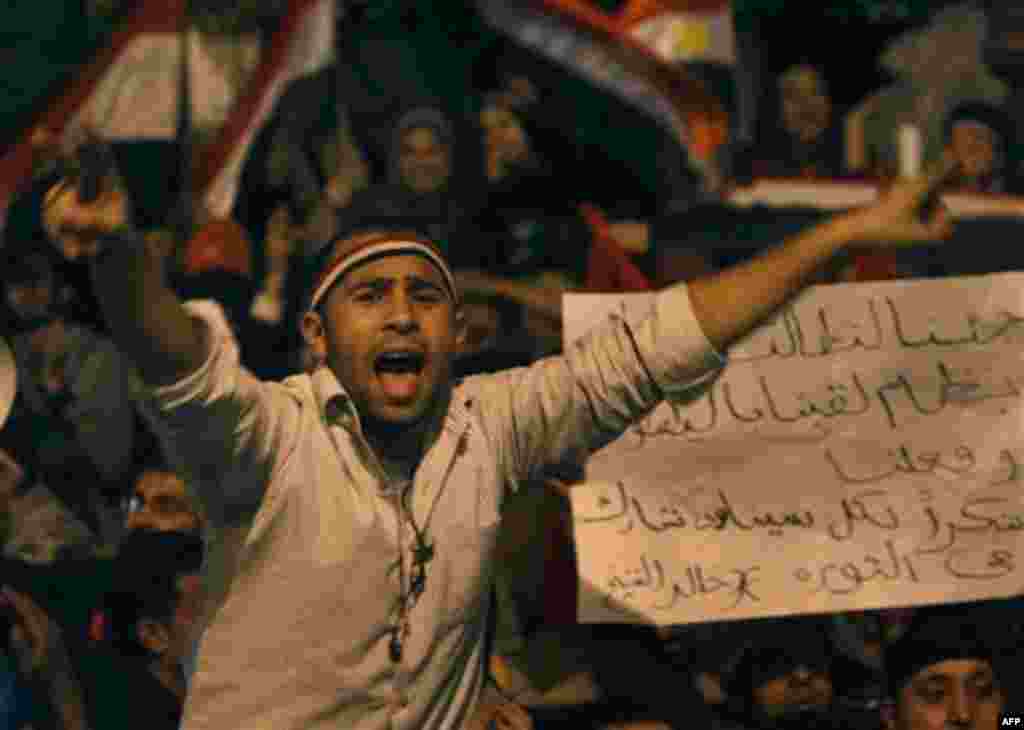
(468, 285, 726, 488)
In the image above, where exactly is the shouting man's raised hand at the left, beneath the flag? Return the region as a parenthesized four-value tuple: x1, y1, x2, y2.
(42, 179, 129, 260)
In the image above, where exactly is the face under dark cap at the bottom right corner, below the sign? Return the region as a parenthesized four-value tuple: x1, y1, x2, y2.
(889, 659, 1004, 730)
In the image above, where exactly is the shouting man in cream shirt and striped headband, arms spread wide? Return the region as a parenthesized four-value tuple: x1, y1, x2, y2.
(39, 156, 949, 730)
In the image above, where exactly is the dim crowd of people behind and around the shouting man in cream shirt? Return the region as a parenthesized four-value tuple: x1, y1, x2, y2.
(0, 2, 1024, 730)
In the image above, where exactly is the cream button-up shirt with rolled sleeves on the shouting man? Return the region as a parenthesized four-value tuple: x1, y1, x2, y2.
(136, 285, 723, 730)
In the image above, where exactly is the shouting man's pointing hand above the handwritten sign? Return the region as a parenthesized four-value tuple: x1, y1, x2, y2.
(850, 161, 956, 247)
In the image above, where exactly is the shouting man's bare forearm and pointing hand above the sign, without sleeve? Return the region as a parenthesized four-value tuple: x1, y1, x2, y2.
(689, 168, 950, 352)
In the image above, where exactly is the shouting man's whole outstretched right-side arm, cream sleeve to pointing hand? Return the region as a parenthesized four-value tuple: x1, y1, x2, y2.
(476, 167, 950, 484)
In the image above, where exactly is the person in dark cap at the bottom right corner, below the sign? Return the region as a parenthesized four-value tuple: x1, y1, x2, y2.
(886, 606, 1021, 730)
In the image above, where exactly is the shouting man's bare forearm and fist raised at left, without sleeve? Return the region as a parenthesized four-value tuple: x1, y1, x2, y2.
(43, 183, 205, 386)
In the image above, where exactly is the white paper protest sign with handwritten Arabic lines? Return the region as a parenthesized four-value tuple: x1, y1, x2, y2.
(564, 273, 1024, 625)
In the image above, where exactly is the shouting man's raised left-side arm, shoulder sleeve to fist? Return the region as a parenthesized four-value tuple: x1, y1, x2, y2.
(44, 175, 299, 524)
